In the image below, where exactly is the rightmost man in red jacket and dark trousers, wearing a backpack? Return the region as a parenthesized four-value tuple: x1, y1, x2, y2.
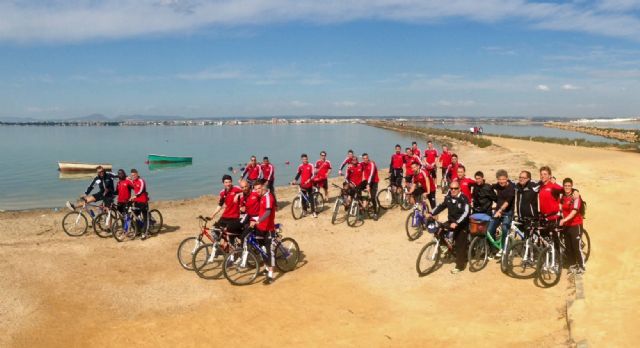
(560, 178, 585, 274)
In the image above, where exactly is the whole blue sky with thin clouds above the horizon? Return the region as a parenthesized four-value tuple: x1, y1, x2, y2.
(0, 0, 640, 118)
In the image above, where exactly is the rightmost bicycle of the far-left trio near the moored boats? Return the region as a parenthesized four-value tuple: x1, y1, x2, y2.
(111, 203, 163, 242)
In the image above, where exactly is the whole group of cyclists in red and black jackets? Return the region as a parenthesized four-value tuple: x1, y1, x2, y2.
(67, 141, 585, 284)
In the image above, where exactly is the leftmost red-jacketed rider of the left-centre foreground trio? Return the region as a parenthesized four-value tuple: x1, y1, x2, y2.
(211, 174, 242, 243)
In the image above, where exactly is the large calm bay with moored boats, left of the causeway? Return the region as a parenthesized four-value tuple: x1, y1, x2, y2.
(0, 124, 424, 210)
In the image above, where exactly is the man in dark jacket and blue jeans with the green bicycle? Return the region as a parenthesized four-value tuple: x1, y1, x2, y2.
(487, 169, 516, 258)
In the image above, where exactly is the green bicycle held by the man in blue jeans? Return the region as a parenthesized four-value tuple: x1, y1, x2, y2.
(468, 216, 524, 273)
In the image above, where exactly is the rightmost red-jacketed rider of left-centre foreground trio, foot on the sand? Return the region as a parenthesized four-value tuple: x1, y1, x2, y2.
(250, 181, 276, 285)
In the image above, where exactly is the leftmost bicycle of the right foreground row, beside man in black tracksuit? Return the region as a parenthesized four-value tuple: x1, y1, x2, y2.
(416, 218, 455, 277)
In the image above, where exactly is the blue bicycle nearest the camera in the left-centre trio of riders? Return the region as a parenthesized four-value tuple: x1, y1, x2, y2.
(222, 224, 300, 285)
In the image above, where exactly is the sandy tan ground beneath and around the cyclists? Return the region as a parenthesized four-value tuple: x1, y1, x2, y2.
(0, 138, 640, 347)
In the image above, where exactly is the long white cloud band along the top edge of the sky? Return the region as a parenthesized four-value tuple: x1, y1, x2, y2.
(0, 0, 640, 42)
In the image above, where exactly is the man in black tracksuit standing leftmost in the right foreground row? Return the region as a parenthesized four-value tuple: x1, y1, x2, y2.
(429, 181, 471, 274)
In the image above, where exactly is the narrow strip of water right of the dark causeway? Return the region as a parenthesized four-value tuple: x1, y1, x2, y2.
(415, 122, 620, 143)
